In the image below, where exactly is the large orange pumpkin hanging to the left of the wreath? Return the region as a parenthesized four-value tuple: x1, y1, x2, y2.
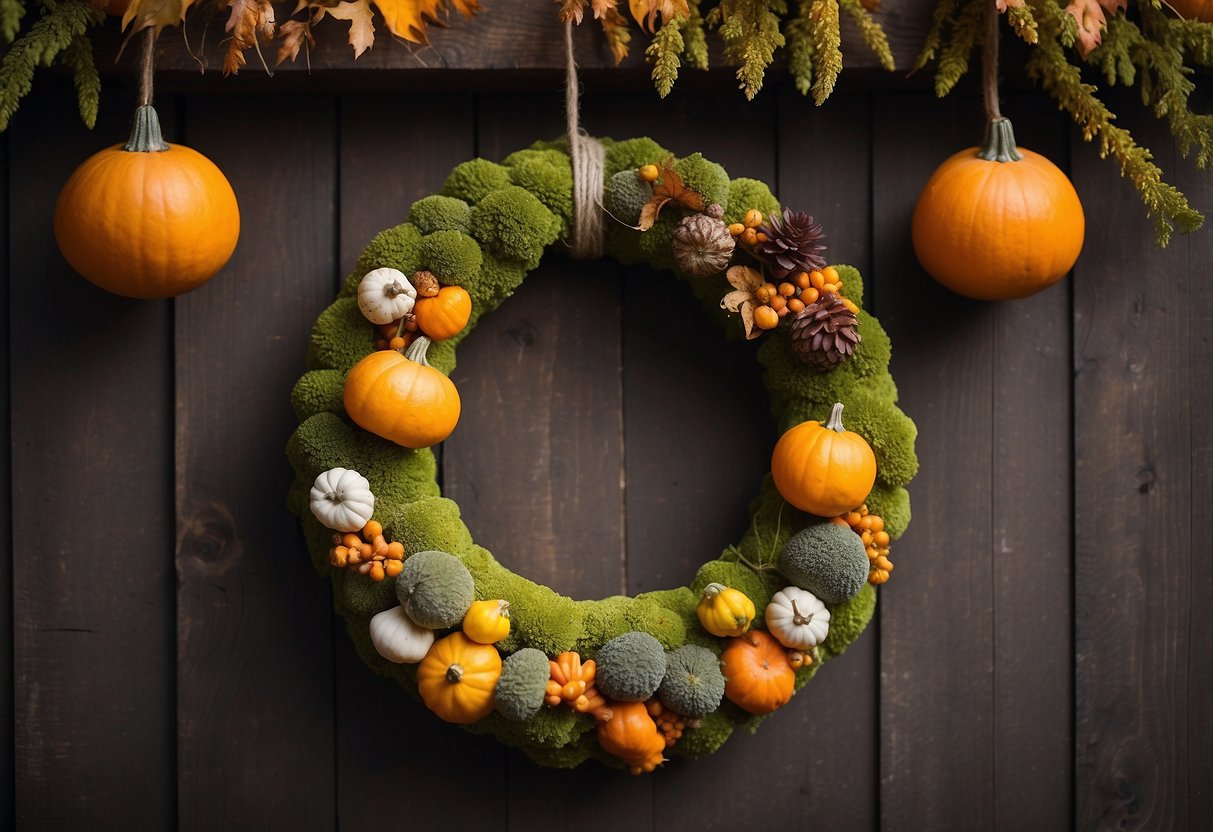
(55, 106, 240, 298)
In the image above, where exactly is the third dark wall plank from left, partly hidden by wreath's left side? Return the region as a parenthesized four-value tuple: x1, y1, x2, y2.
(334, 96, 505, 830)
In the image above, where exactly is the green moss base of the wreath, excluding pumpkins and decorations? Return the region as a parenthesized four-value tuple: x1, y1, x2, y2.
(287, 138, 917, 768)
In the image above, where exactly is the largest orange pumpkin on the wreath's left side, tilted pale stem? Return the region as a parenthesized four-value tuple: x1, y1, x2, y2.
(343, 337, 461, 448)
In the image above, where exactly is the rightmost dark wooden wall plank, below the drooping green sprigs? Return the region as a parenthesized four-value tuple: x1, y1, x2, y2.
(1074, 87, 1213, 830)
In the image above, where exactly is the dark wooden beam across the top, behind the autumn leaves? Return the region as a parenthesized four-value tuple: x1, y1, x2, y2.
(106, 0, 934, 76)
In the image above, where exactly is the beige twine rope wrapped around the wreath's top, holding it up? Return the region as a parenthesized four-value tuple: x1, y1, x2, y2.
(564, 22, 606, 260)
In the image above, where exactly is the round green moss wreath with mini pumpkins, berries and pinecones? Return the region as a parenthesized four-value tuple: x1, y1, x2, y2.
(287, 138, 917, 773)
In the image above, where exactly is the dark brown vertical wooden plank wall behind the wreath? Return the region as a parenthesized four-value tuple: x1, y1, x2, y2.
(0, 74, 1213, 831)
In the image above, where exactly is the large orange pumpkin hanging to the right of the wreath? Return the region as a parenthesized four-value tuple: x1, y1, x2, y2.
(912, 119, 1086, 301)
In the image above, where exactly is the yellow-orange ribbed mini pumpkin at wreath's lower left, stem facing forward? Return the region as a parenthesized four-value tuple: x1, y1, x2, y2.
(417, 632, 501, 725)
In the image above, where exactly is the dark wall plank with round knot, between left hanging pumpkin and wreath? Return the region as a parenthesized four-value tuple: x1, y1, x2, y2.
(176, 97, 337, 830)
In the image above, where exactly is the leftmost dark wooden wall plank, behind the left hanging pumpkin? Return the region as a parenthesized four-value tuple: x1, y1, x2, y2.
(7, 79, 176, 830)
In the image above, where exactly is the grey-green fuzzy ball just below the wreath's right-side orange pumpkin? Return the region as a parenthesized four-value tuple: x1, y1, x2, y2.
(779, 523, 867, 603)
